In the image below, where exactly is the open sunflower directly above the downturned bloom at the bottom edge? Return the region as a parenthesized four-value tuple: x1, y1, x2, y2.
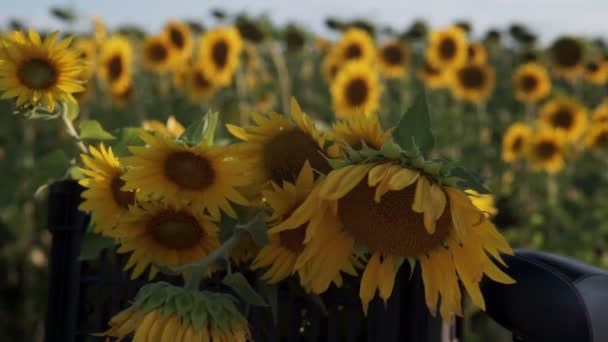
(107, 201, 219, 279)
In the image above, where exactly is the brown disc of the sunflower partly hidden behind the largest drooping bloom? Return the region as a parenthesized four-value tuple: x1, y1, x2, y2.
(263, 129, 330, 184)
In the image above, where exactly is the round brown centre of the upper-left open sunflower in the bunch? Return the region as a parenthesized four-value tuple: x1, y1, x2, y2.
(164, 151, 215, 190)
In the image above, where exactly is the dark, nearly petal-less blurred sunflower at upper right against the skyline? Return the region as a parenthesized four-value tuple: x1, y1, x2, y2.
(549, 37, 586, 80)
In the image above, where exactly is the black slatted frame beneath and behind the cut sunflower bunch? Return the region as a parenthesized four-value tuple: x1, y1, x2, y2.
(46, 181, 441, 342)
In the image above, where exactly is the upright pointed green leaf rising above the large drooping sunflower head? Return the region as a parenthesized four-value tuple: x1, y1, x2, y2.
(393, 90, 435, 153)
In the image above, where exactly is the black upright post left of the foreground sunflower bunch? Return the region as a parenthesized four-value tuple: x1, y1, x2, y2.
(45, 180, 88, 342)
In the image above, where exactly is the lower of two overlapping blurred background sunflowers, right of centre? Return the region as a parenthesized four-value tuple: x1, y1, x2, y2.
(448, 63, 495, 102)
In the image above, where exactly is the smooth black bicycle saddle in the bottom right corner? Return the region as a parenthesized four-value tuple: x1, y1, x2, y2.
(482, 250, 608, 342)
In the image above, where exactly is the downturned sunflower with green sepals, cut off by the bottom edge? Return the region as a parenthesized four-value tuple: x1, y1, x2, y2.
(103, 282, 251, 342)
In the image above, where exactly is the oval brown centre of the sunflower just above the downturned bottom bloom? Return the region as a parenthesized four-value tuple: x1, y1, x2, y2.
(148, 212, 203, 249)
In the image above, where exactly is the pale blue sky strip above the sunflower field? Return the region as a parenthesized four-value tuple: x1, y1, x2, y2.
(0, 0, 608, 41)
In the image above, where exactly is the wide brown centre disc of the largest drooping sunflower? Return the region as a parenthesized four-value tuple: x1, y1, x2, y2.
(338, 180, 451, 257)
